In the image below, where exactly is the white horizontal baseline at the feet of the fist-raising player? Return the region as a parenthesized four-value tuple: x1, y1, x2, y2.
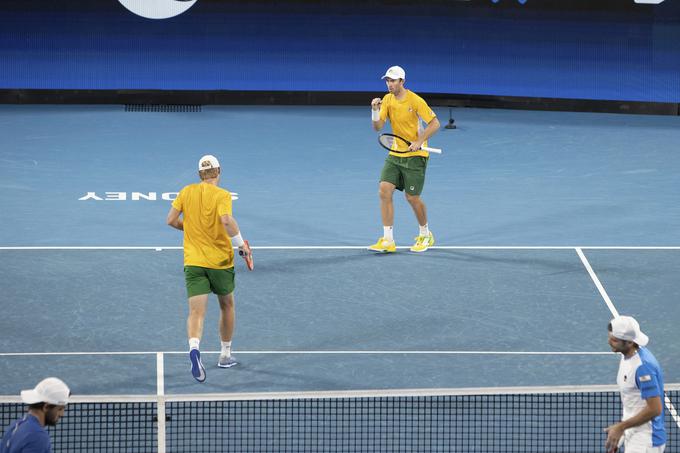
(0, 245, 680, 251)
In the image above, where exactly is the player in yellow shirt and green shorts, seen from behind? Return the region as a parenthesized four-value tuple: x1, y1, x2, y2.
(167, 155, 251, 382)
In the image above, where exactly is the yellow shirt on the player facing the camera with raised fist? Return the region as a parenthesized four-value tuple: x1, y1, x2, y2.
(380, 90, 437, 157)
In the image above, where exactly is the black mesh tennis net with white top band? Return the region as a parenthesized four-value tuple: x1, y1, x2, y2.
(0, 385, 680, 453)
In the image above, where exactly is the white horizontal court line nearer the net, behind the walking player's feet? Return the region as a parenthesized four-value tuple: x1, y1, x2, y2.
(0, 350, 614, 357)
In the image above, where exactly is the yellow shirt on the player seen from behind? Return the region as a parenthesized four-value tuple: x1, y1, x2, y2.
(172, 183, 234, 269)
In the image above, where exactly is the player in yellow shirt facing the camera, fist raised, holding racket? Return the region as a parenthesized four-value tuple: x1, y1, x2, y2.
(369, 66, 439, 252)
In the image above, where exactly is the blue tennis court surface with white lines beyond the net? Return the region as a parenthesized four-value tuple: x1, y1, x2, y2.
(0, 106, 680, 395)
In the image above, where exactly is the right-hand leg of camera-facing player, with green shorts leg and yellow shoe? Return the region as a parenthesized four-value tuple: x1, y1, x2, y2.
(404, 157, 434, 252)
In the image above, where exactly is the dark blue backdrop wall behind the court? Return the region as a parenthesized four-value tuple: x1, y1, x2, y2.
(0, 0, 680, 102)
